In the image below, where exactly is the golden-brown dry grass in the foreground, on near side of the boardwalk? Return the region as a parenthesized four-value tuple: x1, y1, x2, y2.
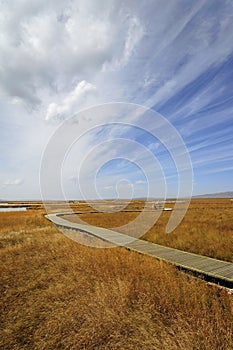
(0, 211, 233, 350)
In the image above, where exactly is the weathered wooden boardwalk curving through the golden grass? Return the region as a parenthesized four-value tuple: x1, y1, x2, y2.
(46, 213, 233, 288)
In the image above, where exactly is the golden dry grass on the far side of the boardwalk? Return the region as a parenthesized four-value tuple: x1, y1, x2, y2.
(64, 199, 233, 262)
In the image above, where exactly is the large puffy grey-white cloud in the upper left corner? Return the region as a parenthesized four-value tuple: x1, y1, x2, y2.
(0, 0, 143, 108)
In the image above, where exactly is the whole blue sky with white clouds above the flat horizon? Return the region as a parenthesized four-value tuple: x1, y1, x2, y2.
(0, 0, 233, 200)
